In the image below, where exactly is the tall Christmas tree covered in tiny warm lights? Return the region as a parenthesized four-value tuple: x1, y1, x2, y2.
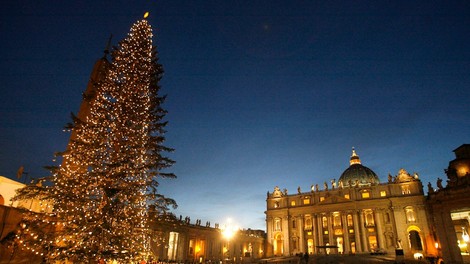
(16, 15, 176, 263)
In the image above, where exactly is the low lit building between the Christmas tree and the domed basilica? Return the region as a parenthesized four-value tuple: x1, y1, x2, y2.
(151, 217, 265, 263)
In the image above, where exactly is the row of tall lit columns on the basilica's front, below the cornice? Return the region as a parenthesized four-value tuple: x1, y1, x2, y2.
(271, 209, 396, 255)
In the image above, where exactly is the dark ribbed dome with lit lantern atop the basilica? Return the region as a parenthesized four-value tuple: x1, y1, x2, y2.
(338, 148, 380, 187)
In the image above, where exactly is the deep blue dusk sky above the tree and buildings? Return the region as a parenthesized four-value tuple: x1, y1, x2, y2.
(0, 0, 470, 229)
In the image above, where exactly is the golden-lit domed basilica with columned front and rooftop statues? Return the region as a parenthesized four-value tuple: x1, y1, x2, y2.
(266, 149, 436, 258)
